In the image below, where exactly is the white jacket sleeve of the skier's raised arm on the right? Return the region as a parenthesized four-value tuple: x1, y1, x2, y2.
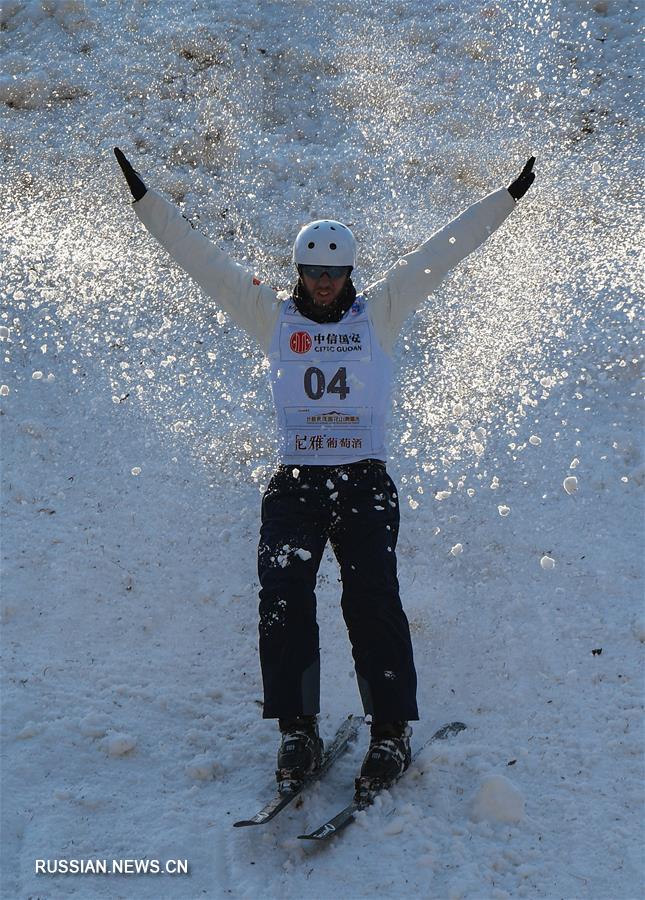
(364, 188, 515, 352)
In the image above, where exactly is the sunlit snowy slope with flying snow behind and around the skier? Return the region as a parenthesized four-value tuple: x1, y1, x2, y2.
(0, 0, 645, 900)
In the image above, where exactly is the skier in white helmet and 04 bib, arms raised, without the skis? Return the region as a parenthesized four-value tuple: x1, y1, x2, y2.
(114, 148, 535, 792)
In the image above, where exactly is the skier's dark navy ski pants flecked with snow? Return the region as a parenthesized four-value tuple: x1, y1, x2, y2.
(258, 460, 419, 722)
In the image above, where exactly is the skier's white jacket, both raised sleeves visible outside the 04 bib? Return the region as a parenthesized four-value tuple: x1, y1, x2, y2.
(134, 188, 515, 353)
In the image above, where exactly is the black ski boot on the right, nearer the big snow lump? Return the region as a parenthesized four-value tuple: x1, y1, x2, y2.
(355, 722, 412, 802)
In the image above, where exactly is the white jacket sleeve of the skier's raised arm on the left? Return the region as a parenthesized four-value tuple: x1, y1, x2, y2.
(134, 190, 279, 350)
